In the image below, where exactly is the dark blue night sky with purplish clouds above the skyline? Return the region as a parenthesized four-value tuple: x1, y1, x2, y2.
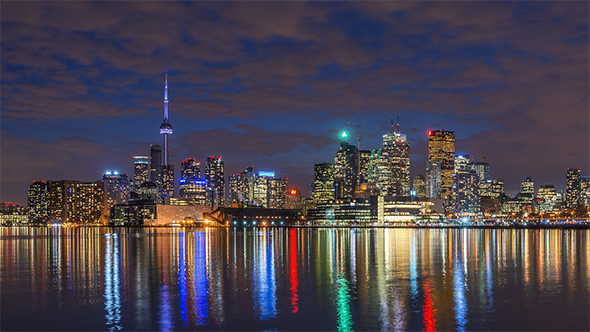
(0, 1, 590, 205)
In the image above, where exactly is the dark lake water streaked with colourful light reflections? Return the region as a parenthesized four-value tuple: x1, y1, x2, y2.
(0, 227, 590, 331)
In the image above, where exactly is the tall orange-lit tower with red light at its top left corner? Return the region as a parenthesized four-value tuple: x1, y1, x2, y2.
(428, 129, 455, 213)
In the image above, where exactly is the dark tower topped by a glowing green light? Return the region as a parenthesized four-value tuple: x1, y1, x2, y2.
(334, 133, 358, 198)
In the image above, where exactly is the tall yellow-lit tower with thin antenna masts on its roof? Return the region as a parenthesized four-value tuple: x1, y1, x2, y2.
(383, 123, 410, 196)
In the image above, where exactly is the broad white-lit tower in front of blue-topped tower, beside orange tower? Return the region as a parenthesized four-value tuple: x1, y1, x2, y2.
(453, 169, 480, 214)
